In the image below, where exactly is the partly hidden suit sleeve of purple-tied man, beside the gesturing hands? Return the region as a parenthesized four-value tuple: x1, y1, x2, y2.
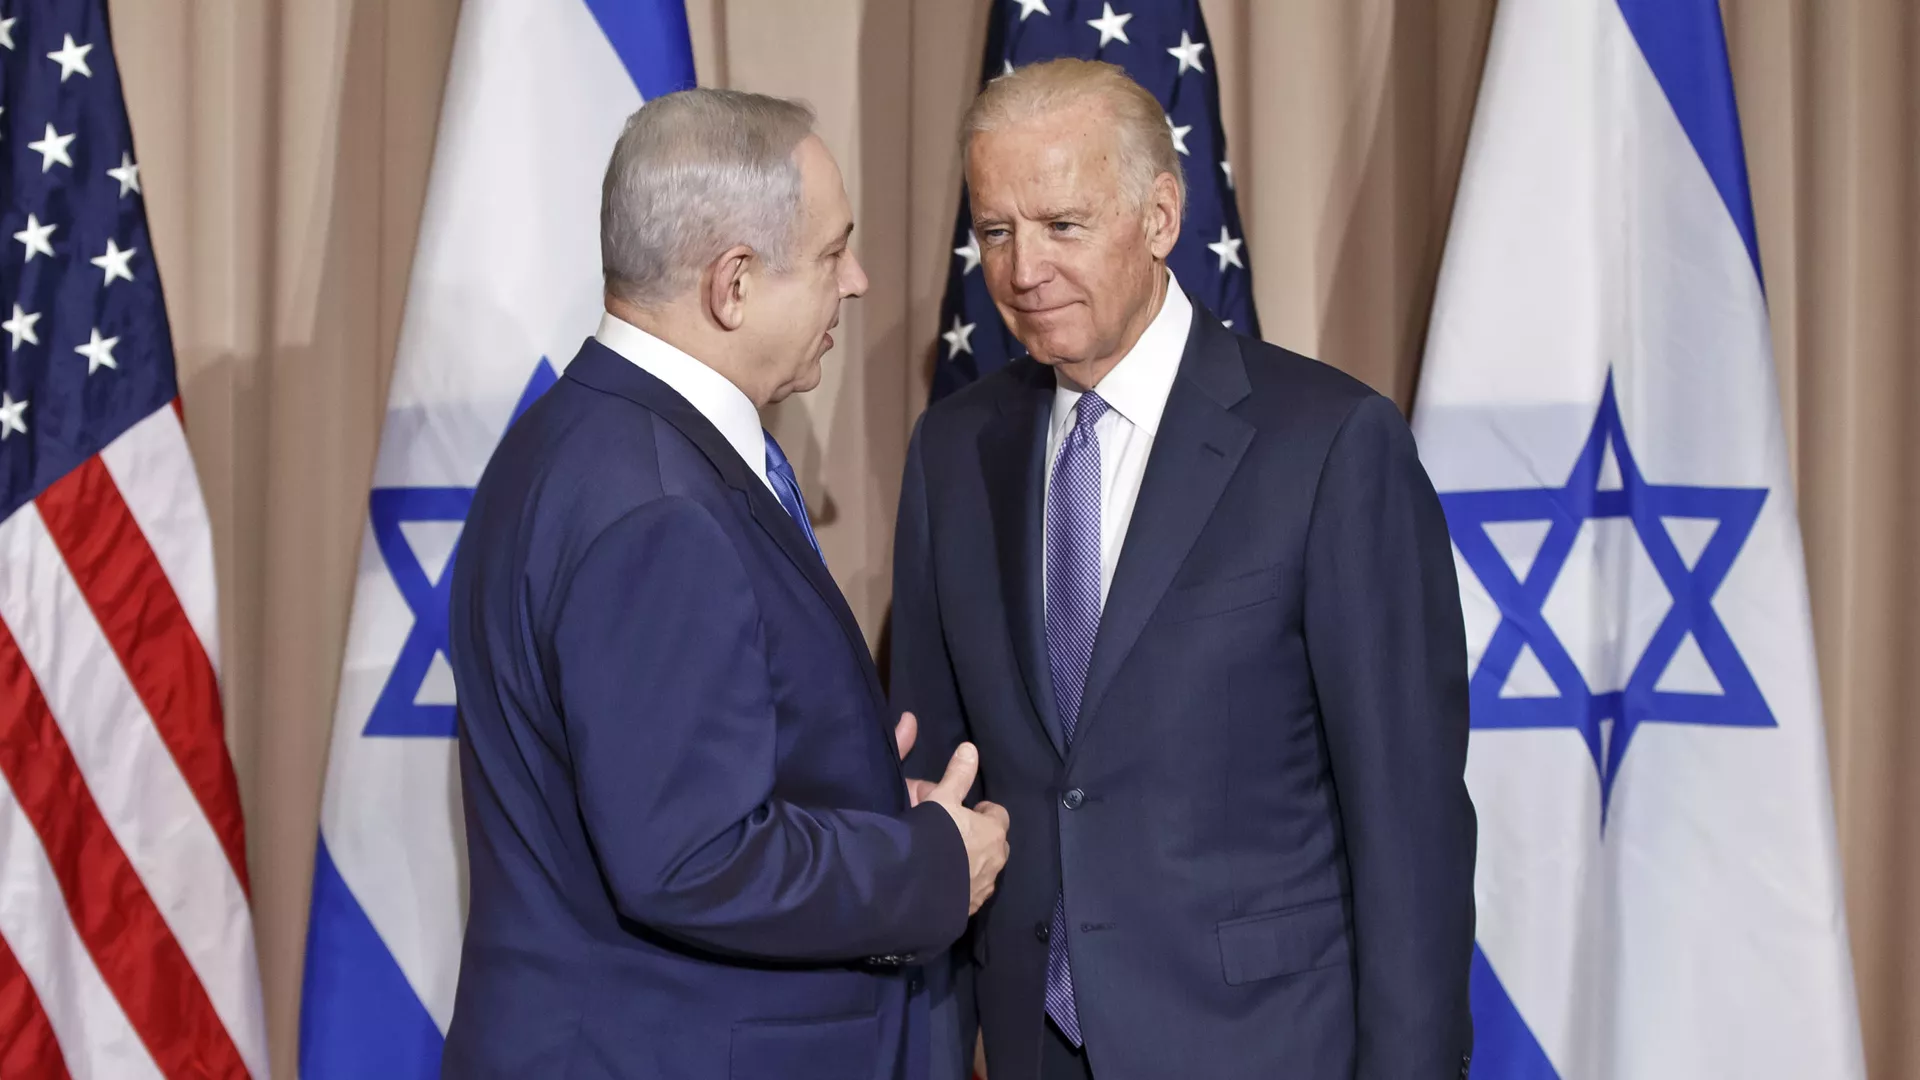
(889, 415, 979, 1080)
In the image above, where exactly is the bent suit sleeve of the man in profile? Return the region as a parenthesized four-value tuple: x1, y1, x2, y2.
(553, 498, 968, 961)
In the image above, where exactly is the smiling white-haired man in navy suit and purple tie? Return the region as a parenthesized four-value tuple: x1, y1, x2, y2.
(893, 60, 1475, 1080)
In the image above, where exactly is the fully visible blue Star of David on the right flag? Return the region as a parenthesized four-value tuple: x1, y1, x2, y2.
(1440, 373, 1776, 814)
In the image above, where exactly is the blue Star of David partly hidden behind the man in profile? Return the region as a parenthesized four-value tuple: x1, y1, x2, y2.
(361, 357, 559, 738)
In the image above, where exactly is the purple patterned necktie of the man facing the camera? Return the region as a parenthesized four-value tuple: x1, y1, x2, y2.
(1046, 394, 1108, 1045)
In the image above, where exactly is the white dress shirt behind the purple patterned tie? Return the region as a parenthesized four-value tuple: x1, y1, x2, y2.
(1041, 271, 1194, 607)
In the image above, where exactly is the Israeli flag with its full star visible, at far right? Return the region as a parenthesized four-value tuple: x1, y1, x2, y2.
(1413, 0, 1862, 1080)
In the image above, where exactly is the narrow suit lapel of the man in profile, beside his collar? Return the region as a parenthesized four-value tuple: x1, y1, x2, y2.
(566, 338, 883, 718)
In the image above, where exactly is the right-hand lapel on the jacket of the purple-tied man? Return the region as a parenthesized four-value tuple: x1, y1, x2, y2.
(1073, 302, 1254, 746)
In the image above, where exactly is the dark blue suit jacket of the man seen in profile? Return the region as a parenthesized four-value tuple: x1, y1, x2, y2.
(444, 340, 968, 1080)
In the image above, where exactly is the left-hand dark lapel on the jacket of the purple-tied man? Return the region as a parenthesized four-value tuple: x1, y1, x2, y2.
(979, 361, 1066, 753)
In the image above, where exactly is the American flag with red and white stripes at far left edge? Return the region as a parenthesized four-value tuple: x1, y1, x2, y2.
(0, 0, 267, 1080)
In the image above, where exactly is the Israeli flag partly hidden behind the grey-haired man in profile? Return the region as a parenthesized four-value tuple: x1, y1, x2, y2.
(300, 0, 693, 1080)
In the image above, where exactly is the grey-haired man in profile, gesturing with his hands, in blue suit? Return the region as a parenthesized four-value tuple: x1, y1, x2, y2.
(444, 90, 1006, 1080)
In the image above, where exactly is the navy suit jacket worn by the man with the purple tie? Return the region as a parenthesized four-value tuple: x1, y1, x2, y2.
(893, 302, 1475, 1080)
